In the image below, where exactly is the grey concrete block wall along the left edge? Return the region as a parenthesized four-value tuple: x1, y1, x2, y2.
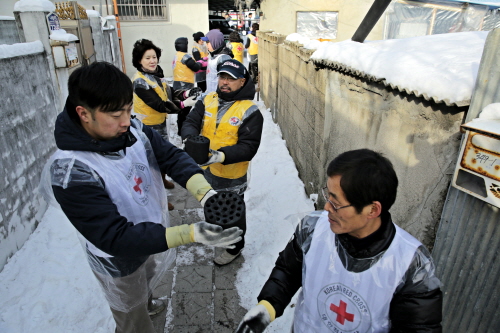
(0, 53, 60, 270)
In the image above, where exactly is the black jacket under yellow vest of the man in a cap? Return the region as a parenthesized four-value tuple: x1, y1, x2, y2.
(181, 67, 264, 165)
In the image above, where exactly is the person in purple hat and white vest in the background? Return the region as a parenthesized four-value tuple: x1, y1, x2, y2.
(201, 29, 233, 93)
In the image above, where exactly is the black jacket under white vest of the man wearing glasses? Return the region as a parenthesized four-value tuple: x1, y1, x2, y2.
(257, 213, 442, 333)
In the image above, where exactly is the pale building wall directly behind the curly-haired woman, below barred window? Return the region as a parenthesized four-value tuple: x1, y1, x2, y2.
(120, 0, 208, 77)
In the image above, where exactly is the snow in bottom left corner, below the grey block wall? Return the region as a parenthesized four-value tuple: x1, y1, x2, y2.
(0, 207, 115, 333)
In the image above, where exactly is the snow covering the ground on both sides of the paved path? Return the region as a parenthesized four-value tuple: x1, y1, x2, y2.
(0, 97, 314, 333)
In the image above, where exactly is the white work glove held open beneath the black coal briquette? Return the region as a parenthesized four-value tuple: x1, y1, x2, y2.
(193, 222, 243, 249)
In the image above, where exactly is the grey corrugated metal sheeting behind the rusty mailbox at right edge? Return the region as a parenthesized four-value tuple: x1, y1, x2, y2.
(432, 29, 500, 333)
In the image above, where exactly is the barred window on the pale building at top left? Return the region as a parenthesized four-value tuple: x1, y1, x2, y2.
(116, 0, 168, 21)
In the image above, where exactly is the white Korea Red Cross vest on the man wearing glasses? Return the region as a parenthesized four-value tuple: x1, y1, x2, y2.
(294, 212, 421, 333)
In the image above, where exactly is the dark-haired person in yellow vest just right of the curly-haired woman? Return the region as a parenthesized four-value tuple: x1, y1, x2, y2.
(172, 37, 207, 90)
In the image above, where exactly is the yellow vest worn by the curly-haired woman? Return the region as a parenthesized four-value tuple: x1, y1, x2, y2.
(132, 72, 168, 125)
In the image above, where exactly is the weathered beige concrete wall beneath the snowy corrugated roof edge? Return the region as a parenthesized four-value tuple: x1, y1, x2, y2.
(259, 32, 466, 248)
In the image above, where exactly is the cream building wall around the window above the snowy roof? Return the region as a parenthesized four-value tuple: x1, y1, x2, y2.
(260, 0, 384, 42)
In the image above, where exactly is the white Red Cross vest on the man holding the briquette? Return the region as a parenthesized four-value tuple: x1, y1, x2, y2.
(52, 126, 169, 258)
